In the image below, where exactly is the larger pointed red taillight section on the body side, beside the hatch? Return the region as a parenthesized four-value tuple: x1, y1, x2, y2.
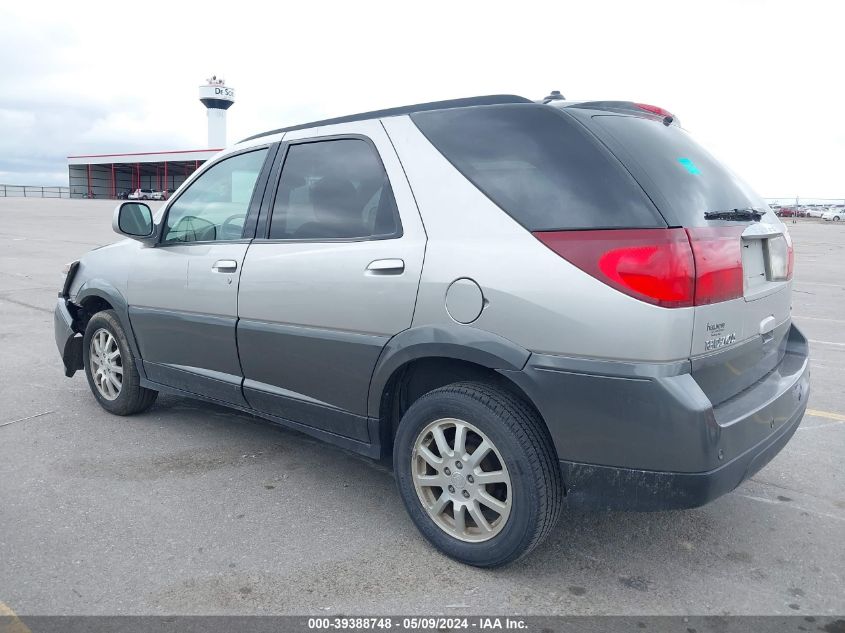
(534, 229, 695, 308)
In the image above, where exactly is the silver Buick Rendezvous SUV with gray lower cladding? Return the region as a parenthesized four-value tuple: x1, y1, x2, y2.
(55, 96, 809, 567)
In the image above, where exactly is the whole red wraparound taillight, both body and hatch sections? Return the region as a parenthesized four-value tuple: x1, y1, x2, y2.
(534, 227, 745, 308)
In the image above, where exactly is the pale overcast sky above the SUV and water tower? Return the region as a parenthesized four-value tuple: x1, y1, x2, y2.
(0, 0, 845, 198)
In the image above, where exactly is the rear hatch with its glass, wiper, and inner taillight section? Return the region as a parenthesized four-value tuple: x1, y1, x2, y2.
(565, 104, 792, 405)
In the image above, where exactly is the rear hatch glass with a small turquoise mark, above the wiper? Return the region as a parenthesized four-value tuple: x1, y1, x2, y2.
(592, 115, 768, 226)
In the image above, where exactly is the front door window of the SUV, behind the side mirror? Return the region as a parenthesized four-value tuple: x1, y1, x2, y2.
(162, 149, 267, 242)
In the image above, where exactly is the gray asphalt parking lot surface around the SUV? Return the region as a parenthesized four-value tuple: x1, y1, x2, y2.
(0, 199, 845, 615)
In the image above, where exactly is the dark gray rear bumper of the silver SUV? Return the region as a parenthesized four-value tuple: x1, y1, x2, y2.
(501, 326, 810, 509)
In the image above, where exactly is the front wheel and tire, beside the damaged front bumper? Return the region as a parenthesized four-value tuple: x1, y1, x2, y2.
(82, 310, 158, 415)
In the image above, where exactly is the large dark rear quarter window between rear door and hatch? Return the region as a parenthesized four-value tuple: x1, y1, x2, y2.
(411, 104, 666, 231)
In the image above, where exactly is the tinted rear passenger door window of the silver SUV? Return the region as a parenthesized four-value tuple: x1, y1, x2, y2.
(270, 139, 400, 239)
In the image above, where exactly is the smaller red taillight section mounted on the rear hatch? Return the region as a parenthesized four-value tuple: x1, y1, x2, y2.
(687, 225, 746, 306)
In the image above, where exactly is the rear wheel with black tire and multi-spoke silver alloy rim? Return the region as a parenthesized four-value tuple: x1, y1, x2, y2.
(393, 382, 563, 567)
